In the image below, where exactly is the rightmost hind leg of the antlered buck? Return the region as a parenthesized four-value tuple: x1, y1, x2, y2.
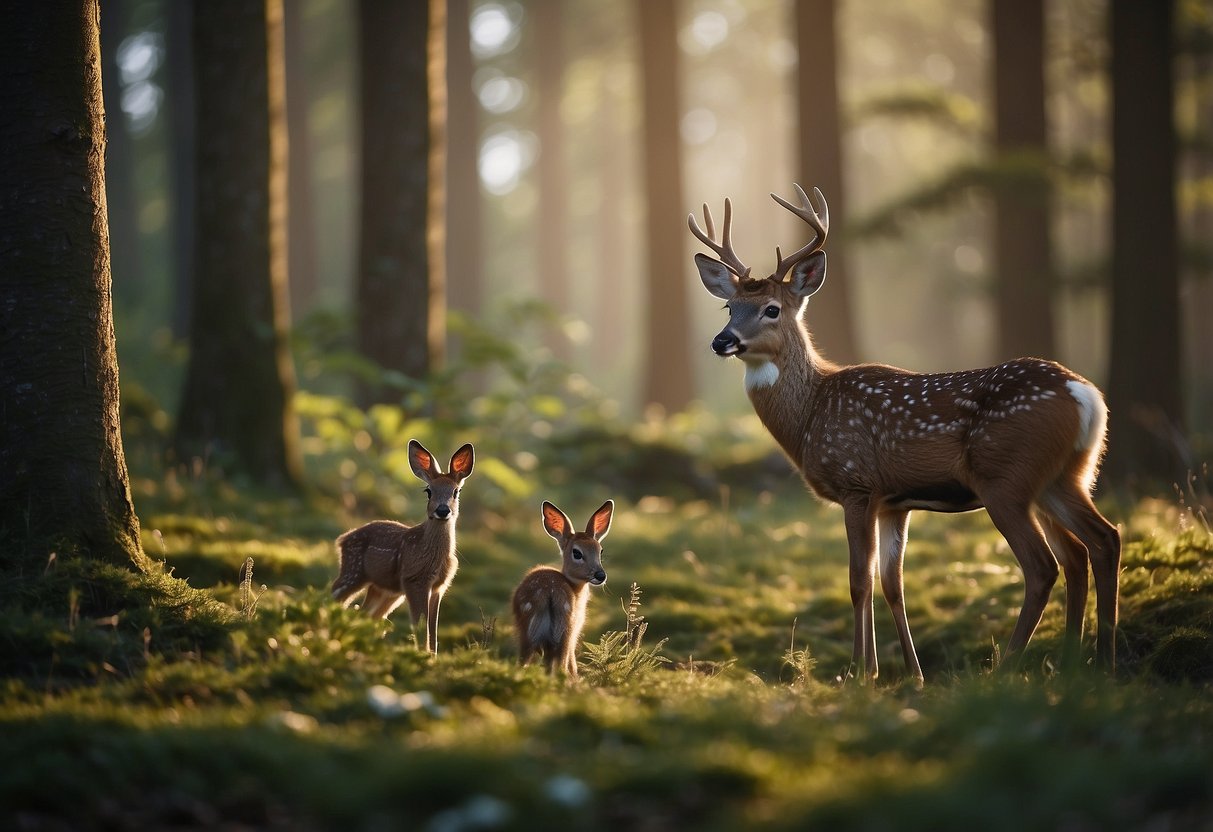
(1046, 486, 1121, 671)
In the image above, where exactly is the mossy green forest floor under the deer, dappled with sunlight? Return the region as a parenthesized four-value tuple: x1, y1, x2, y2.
(0, 408, 1213, 831)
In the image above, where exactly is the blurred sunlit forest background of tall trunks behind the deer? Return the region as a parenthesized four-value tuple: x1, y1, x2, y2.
(102, 0, 1213, 494)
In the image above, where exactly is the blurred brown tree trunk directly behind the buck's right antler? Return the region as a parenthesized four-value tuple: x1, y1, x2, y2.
(792, 0, 859, 364)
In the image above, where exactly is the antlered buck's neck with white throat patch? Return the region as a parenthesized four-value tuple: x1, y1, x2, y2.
(746, 323, 836, 461)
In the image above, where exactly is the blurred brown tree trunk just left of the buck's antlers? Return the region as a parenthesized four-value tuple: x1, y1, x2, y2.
(634, 0, 695, 412)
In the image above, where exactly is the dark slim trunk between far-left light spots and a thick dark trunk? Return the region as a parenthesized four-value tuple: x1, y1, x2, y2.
(165, 0, 198, 338)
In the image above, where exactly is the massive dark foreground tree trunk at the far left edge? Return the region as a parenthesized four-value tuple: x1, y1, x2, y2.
(0, 0, 144, 569)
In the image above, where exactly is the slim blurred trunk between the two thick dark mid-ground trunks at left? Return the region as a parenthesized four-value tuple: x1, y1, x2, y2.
(283, 0, 319, 320)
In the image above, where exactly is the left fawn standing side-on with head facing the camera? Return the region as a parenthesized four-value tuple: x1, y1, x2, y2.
(332, 439, 475, 655)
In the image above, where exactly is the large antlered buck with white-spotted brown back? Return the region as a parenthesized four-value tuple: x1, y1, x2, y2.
(688, 184, 1121, 686)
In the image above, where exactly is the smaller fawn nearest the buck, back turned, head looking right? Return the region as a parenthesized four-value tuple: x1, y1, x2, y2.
(513, 500, 615, 679)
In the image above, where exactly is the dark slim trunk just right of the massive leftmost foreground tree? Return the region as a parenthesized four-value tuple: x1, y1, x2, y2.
(101, 0, 144, 309)
